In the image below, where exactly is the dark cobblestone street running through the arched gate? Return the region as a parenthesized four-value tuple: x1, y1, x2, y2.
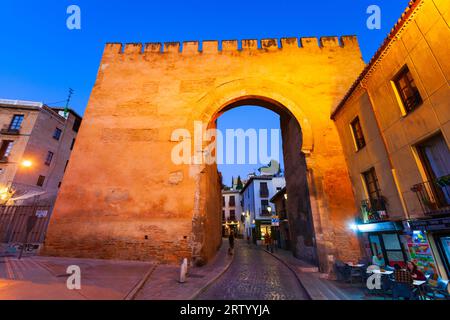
(198, 241, 309, 300)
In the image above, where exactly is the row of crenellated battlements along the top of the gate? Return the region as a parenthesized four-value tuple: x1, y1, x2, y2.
(105, 36, 359, 55)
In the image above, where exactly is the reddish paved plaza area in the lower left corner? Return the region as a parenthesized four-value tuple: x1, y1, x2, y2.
(0, 257, 154, 300)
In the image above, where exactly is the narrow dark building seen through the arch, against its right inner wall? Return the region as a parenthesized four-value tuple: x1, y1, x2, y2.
(270, 187, 291, 250)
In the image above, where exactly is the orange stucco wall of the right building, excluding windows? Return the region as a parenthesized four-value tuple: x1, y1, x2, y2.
(336, 0, 450, 219)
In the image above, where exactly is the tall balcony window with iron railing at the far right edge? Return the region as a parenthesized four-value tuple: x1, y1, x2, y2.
(411, 134, 450, 214)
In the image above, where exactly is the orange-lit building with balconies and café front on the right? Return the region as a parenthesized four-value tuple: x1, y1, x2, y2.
(332, 0, 450, 279)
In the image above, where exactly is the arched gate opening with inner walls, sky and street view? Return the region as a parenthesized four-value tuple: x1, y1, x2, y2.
(193, 97, 320, 264)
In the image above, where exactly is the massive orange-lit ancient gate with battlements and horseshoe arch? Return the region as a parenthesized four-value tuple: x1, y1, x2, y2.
(44, 36, 364, 271)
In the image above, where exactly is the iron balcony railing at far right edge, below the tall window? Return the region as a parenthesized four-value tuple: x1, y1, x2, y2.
(411, 175, 450, 215)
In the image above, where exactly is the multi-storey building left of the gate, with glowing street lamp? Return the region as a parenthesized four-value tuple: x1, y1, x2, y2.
(0, 99, 82, 206)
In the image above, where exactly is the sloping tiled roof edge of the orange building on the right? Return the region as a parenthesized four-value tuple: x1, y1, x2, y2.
(331, 0, 422, 120)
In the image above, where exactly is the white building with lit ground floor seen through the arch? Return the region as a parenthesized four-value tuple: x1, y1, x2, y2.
(241, 175, 286, 243)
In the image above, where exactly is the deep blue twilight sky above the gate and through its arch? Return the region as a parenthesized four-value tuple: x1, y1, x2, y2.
(0, 0, 408, 183)
